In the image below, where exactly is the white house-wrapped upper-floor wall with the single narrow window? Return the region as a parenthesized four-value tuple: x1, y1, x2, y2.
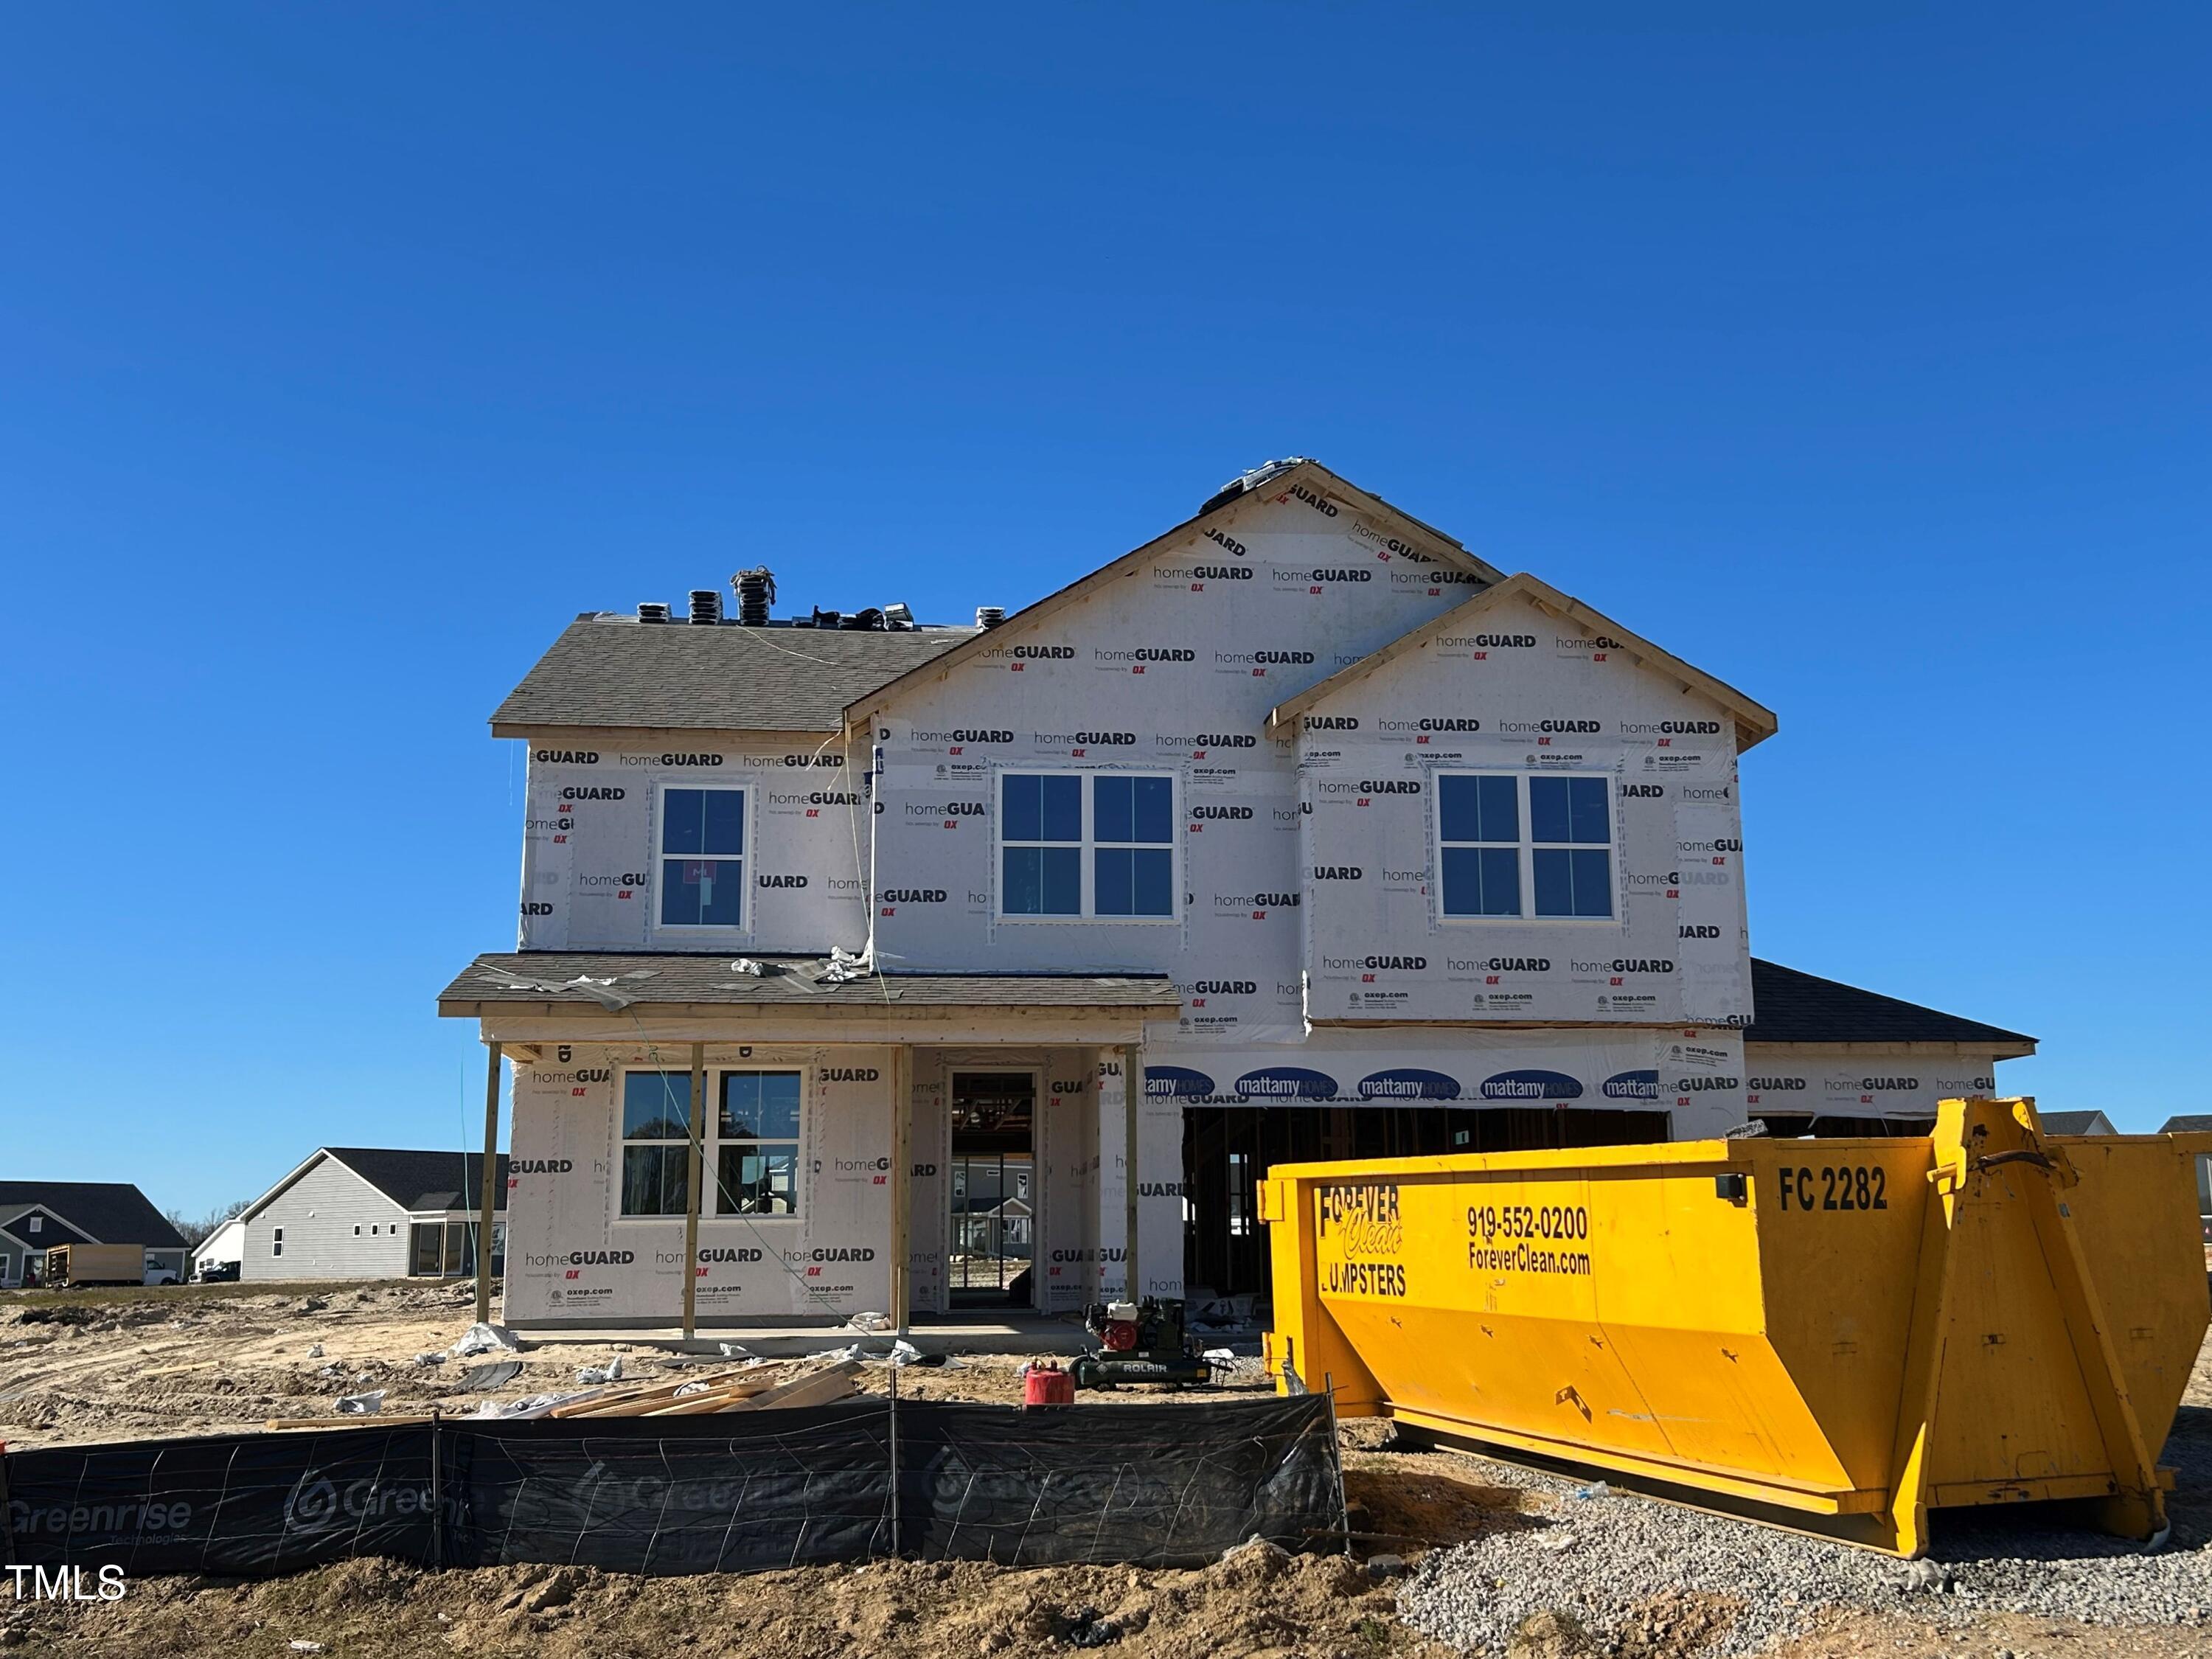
(520, 730, 867, 953)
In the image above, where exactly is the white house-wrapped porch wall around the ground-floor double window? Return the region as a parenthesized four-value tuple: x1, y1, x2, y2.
(504, 1044, 891, 1325)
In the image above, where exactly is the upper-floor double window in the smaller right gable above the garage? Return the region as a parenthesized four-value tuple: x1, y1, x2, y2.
(1436, 772, 1613, 922)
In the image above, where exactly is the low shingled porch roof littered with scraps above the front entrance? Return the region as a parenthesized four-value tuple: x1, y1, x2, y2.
(438, 951, 1181, 1015)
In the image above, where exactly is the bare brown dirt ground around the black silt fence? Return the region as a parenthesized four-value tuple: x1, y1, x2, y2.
(0, 1283, 2212, 1659)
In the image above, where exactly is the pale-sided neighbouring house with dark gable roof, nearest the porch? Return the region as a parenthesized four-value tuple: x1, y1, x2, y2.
(231, 1146, 509, 1281)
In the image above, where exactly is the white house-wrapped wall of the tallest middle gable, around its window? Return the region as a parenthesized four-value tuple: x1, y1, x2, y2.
(872, 491, 1480, 1042)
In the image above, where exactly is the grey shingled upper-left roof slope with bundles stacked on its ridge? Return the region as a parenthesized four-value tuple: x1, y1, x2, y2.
(491, 615, 975, 732)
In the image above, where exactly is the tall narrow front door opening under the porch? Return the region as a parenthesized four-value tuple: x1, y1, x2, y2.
(947, 1071, 1037, 1307)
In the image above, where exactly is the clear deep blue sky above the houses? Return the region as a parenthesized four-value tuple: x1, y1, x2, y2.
(0, 2, 2212, 1208)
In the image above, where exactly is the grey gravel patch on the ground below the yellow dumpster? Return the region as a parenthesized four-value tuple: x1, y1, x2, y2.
(1398, 1409, 2212, 1655)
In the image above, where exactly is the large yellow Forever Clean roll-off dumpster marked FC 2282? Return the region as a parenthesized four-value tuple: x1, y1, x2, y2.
(1261, 1099, 2212, 1555)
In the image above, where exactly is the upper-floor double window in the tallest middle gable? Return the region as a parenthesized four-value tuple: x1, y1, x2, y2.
(998, 772, 1175, 920)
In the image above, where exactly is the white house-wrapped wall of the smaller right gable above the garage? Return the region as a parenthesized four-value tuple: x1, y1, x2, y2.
(1298, 584, 1752, 1024)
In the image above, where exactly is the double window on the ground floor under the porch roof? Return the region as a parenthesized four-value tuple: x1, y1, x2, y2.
(622, 1071, 803, 1217)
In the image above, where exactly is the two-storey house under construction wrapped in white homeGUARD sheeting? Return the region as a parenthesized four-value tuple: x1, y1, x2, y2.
(440, 460, 2035, 1325)
